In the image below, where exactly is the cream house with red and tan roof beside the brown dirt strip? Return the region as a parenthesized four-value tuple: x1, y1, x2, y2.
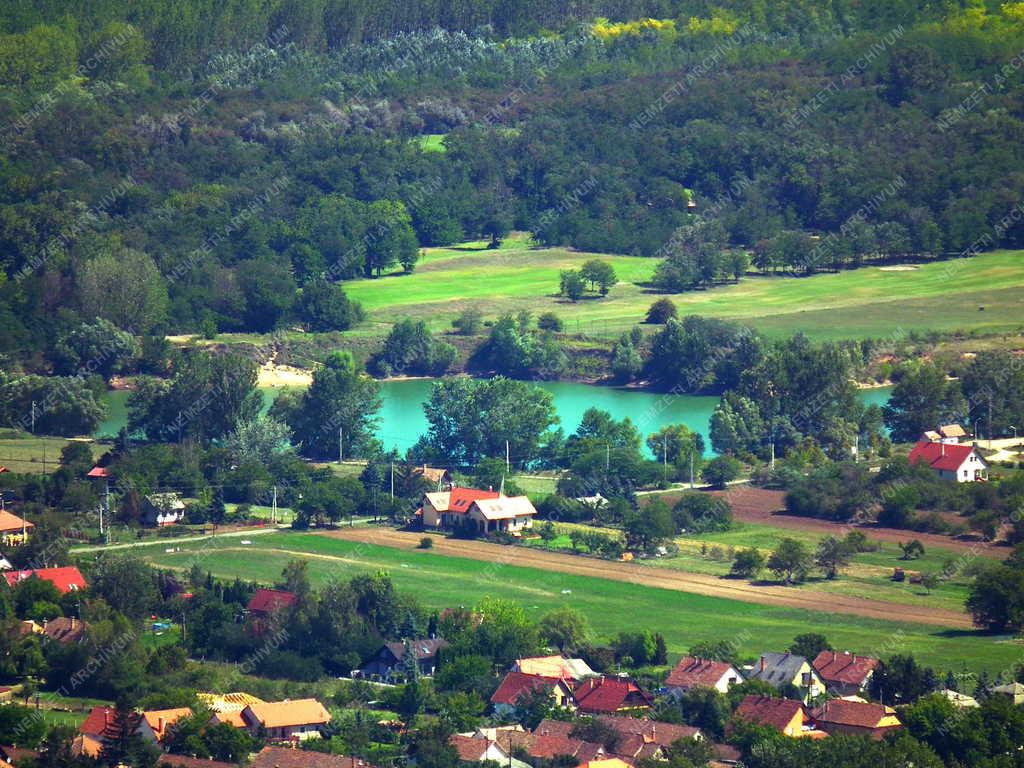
(417, 485, 537, 534)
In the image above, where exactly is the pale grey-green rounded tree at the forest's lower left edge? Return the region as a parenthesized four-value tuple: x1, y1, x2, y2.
(78, 249, 168, 335)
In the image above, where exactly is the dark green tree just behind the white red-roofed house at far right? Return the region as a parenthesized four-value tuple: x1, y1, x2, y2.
(883, 364, 967, 442)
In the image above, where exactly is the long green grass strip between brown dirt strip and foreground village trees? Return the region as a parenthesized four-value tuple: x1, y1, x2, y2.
(130, 532, 1024, 673)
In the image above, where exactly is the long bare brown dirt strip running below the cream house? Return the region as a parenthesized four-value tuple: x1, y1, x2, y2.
(322, 527, 972, 629)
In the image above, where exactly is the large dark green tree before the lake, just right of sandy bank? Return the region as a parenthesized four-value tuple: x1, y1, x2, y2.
(269, 352, 381, 459)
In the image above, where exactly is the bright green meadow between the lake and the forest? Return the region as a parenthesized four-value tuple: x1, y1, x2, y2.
(345, 234, 1024, 339)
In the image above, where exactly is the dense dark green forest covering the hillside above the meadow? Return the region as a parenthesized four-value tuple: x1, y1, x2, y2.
(0, 0, 1024, 360)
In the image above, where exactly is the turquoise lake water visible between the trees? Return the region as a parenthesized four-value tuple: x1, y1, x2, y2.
(95, 380, 891, 454)
